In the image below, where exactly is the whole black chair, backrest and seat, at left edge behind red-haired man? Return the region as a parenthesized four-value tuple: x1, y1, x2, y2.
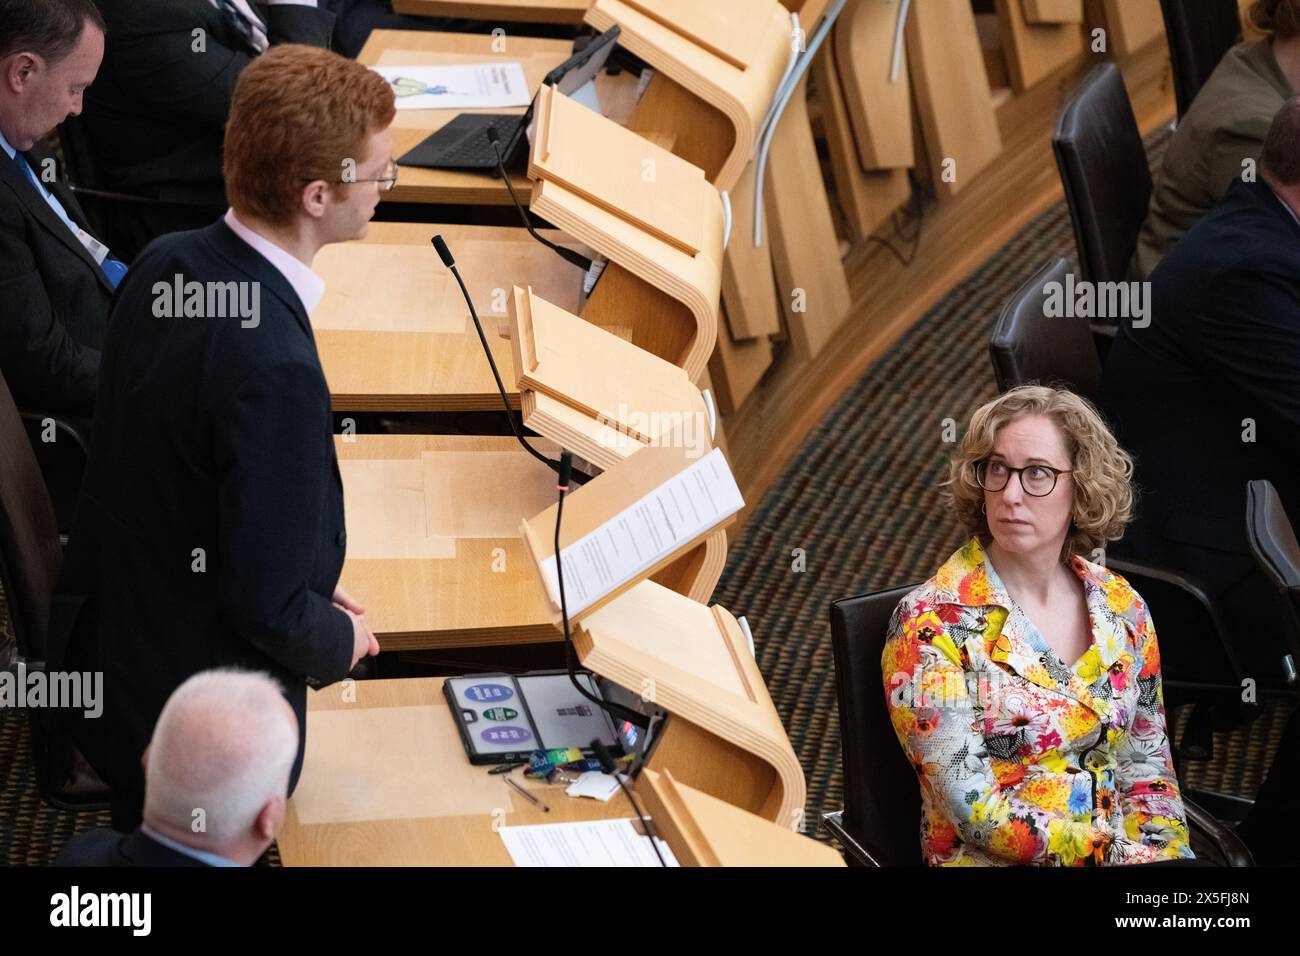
(0, 366, 108, 809)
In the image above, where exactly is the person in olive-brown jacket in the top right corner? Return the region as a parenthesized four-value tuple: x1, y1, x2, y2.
(1134, 0, 1300, 278)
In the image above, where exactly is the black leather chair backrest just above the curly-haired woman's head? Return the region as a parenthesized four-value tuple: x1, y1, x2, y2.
(988, 259, 1101, 401)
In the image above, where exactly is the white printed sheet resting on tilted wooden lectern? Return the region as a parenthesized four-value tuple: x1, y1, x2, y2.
(541, 449, 745, 617)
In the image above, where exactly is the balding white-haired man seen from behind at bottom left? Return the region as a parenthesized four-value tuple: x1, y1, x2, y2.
(55, 670, 298, 866)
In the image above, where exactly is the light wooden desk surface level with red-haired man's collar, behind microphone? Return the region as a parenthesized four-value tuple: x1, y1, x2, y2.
(312, 222, 582, 411)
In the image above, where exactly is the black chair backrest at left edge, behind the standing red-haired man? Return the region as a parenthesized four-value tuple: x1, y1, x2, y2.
(0, 376, 62, 661)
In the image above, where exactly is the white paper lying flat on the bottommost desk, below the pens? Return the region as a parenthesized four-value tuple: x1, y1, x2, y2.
(501, 819, 679, 866)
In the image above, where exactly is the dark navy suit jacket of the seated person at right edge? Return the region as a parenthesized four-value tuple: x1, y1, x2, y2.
(1101, 181, 1300, 671)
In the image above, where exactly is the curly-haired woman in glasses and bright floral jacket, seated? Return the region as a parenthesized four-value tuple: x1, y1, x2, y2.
(881, 386, 1192, 866)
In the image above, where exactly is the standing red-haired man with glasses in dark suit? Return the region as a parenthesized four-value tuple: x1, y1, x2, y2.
(49, 46, 384, 829)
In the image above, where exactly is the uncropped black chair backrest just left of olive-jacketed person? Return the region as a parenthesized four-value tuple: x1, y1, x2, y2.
(1052, 62, 1152, 282)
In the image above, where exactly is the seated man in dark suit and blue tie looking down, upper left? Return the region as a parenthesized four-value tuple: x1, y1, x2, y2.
(0, 0, 126, 415)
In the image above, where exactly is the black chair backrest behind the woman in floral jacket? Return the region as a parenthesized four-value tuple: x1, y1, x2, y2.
(831, 584, 924, 866)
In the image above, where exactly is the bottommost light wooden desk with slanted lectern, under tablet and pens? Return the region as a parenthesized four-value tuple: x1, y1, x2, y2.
(278, 678, 844, 866)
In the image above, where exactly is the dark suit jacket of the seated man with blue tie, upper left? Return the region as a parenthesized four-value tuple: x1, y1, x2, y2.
(0, 141, 113, 414)
